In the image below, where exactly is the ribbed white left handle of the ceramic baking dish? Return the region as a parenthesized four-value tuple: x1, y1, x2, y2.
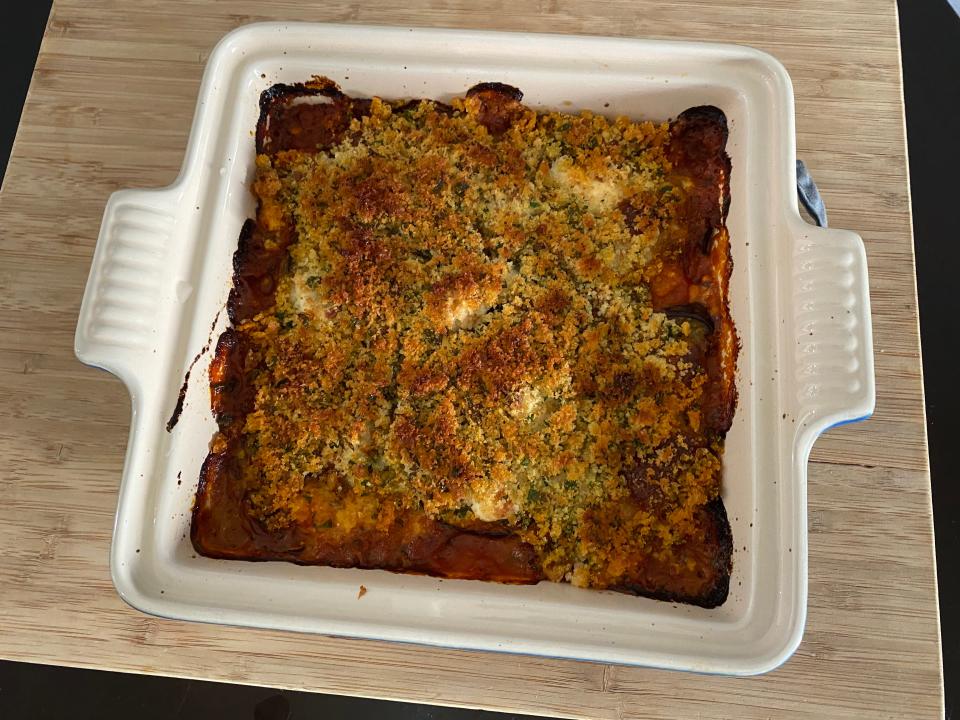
(74, 187, 180, 389)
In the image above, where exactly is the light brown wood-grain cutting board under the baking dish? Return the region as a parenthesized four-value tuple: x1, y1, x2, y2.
(0, 0, 942, 718)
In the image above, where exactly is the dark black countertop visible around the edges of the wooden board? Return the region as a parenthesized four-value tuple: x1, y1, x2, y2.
(0, 0, 960, 720)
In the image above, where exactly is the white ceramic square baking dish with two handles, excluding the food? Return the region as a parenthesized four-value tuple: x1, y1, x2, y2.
(76, 24, 874, 674)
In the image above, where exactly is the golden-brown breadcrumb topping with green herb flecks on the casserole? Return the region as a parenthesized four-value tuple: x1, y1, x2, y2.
(234, 98, 722, 587)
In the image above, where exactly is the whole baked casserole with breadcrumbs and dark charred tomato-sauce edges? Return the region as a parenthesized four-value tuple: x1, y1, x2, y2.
(191, 78, 738, 607)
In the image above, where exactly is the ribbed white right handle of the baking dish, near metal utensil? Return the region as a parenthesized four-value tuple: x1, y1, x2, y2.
(793, 223, 876, 434)
